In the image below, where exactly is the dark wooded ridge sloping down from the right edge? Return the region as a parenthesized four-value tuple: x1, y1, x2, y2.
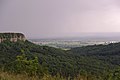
(71, 42, 120, 56)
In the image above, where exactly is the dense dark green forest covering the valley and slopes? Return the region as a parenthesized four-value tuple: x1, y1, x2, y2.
(0, 41, 120, 80)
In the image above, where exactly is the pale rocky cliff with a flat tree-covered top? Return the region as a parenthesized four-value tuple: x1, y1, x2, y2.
(0, 33, 26, 43)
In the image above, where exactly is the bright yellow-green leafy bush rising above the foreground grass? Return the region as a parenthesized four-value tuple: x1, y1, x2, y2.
(6, 54, 47, 77)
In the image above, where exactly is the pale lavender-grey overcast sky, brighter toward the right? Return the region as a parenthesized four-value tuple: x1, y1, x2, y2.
(0, 0, 120, 38)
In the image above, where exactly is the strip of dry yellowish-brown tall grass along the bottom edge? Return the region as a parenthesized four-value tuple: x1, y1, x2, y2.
(0, 71, 87, 80)
